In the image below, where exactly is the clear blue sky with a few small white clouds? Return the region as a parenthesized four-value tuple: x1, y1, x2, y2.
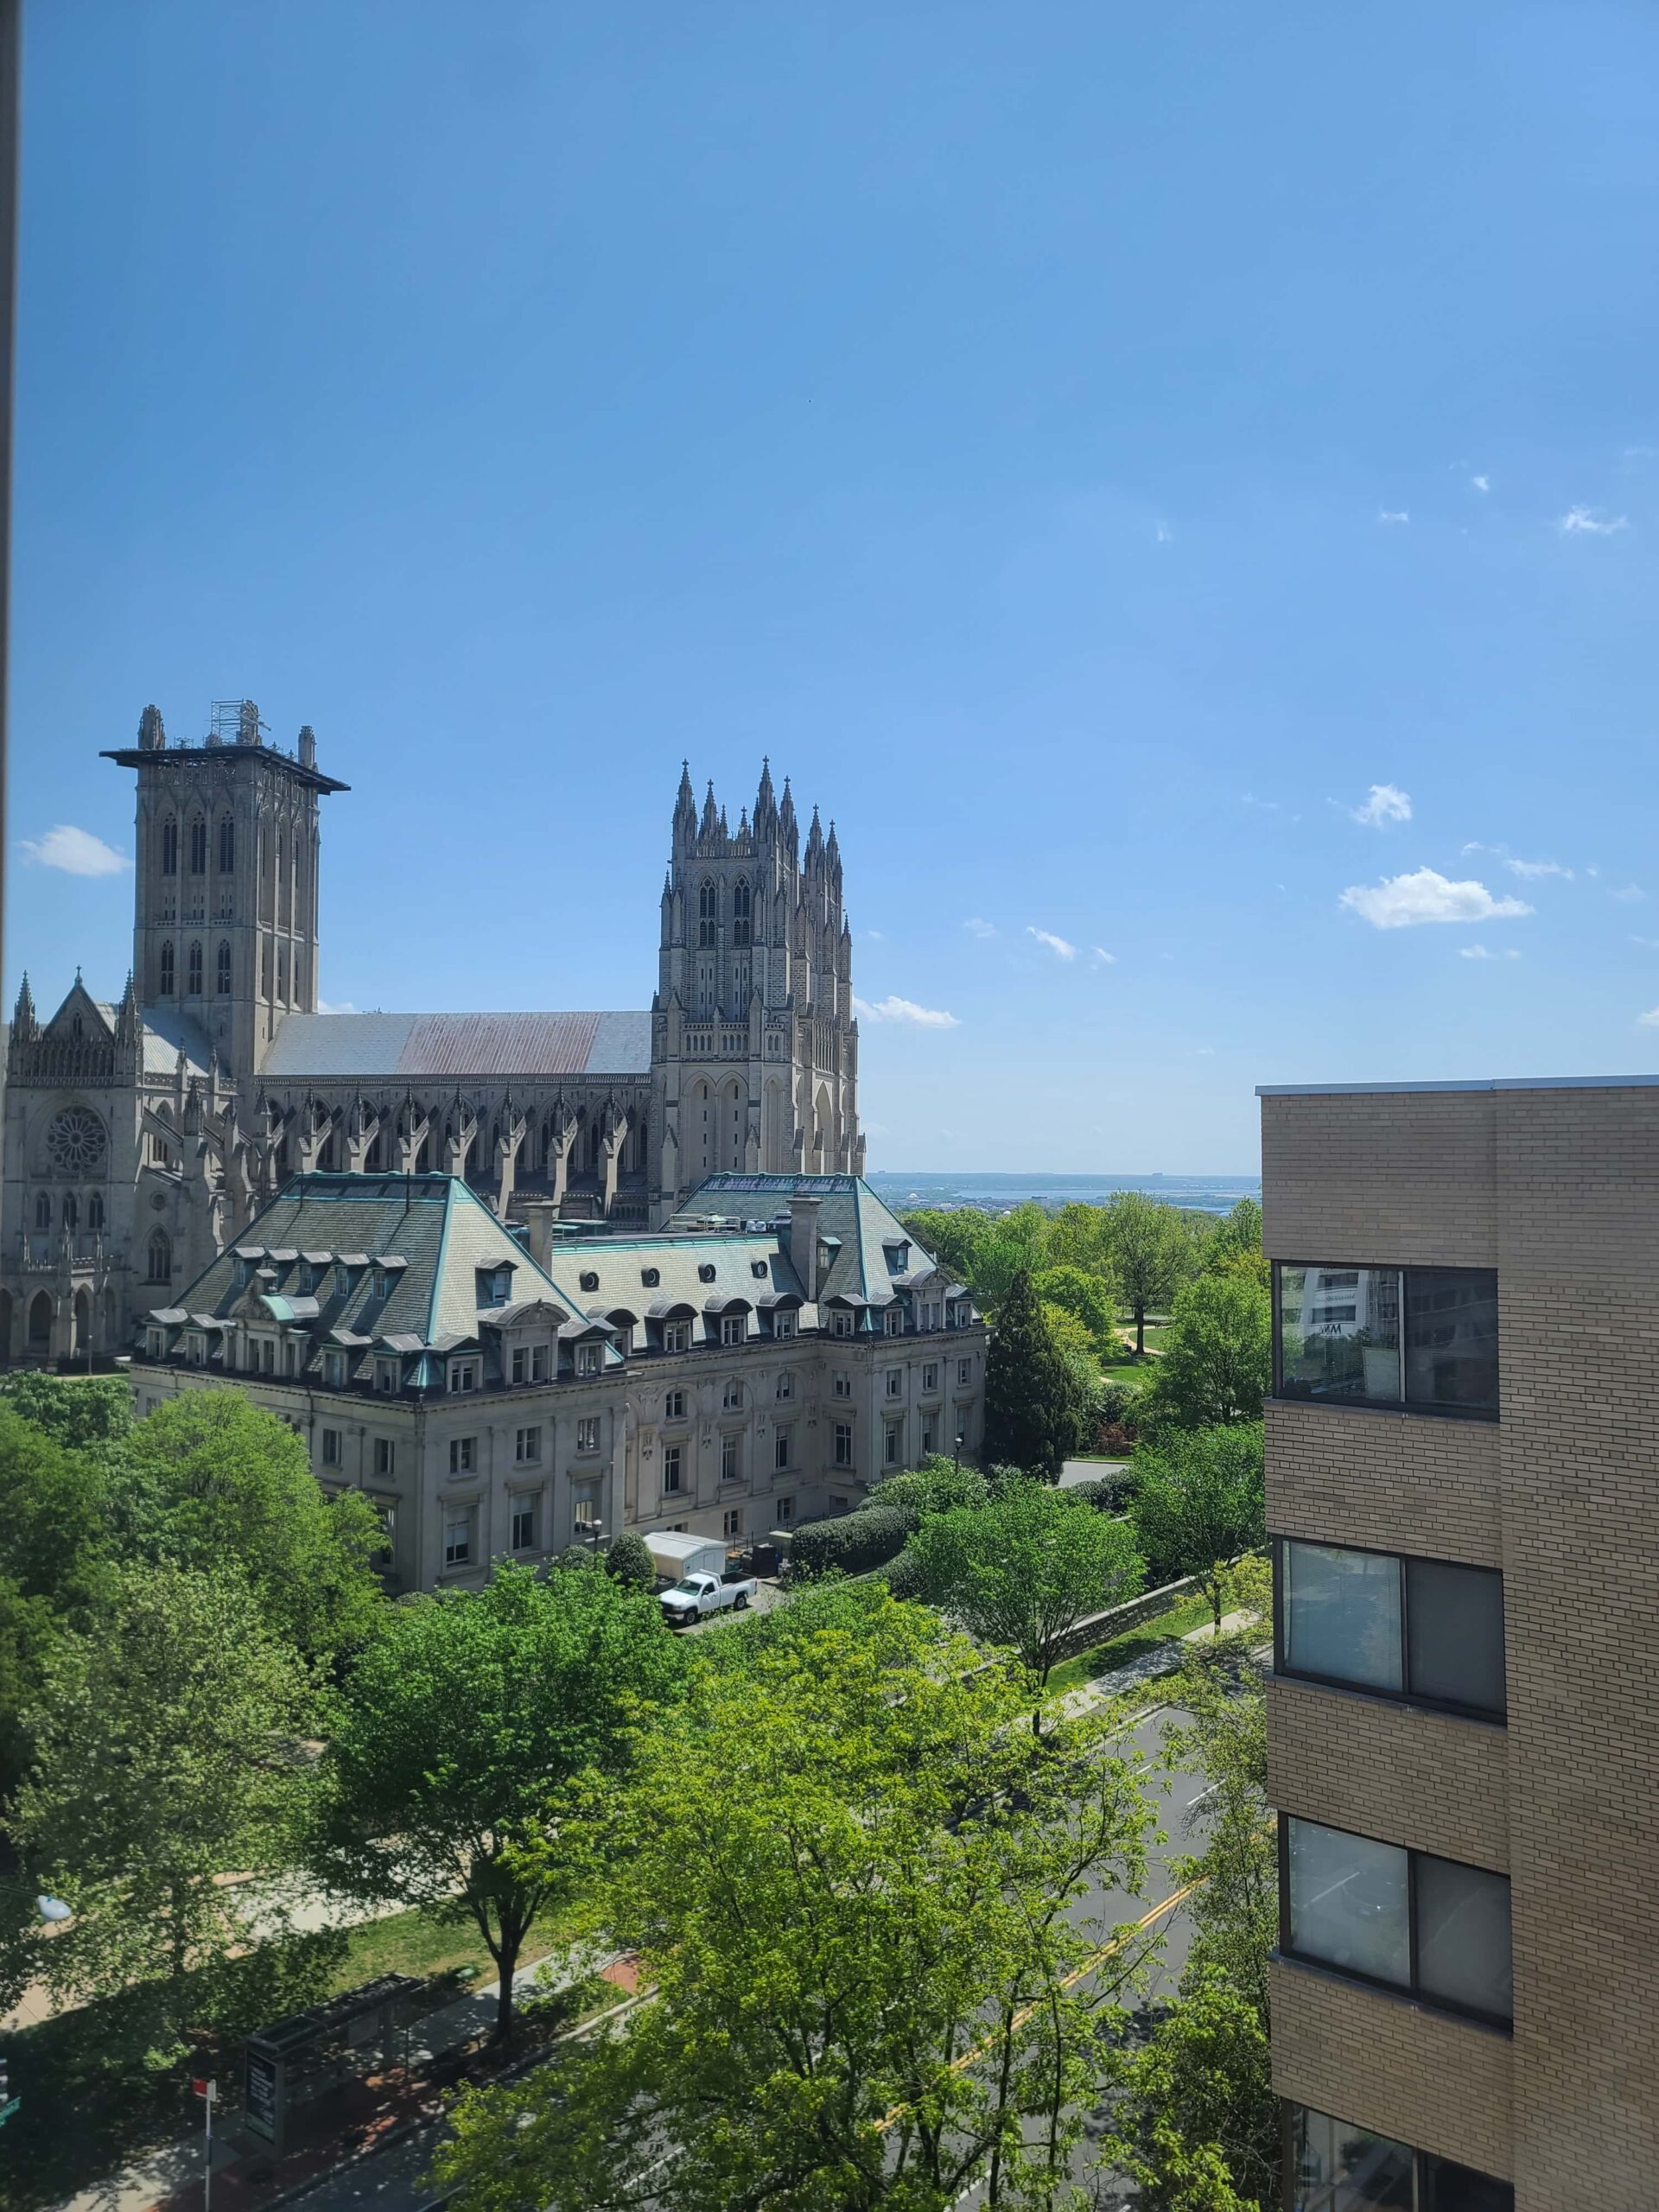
(7, 0, 1659, 1173)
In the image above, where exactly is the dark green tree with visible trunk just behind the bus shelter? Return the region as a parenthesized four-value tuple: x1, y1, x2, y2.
(315, 1564, 681, 2037)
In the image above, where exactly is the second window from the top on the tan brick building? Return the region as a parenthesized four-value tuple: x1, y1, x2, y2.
(1274, 1537, 1506, 1721)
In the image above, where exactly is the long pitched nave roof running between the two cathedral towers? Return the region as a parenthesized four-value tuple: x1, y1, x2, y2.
(259, 1013, 651, 1079)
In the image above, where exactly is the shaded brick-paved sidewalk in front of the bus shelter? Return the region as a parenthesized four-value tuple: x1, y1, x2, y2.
(60, 1951, 632, 2212)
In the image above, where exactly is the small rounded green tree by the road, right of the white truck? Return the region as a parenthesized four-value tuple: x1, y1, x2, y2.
(909, 1482, 1144, 1721)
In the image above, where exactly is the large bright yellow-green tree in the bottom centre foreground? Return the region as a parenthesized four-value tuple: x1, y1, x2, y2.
(435, 1591, 1150, 2212)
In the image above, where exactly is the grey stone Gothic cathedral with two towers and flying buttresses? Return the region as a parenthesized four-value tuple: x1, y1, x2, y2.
(0, 699, 865, 1363)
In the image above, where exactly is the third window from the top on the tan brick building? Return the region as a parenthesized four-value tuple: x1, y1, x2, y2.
(1279, 1816, 1513, 2024)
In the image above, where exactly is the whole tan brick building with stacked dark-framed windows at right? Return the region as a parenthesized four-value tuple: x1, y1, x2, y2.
(1263, 1077, 1659, 2212)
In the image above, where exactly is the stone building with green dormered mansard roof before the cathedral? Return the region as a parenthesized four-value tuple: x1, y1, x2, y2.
(133, 1170, 987, 1591)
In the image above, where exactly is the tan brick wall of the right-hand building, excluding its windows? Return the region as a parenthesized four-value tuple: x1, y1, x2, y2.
(1263, 1086, 1659, 2212)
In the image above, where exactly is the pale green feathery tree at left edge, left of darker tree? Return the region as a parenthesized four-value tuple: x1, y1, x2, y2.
(9, 1564, 327, 2066)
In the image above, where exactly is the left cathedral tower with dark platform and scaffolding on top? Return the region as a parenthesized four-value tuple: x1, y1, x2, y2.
(104, 699, 347, 1082)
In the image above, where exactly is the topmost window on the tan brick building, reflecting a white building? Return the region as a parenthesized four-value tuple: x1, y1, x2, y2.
(1274, 1261, 1497, 1421)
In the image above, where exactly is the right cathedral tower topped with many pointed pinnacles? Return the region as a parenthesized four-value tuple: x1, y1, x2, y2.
(651, 766, 865, 1221)
